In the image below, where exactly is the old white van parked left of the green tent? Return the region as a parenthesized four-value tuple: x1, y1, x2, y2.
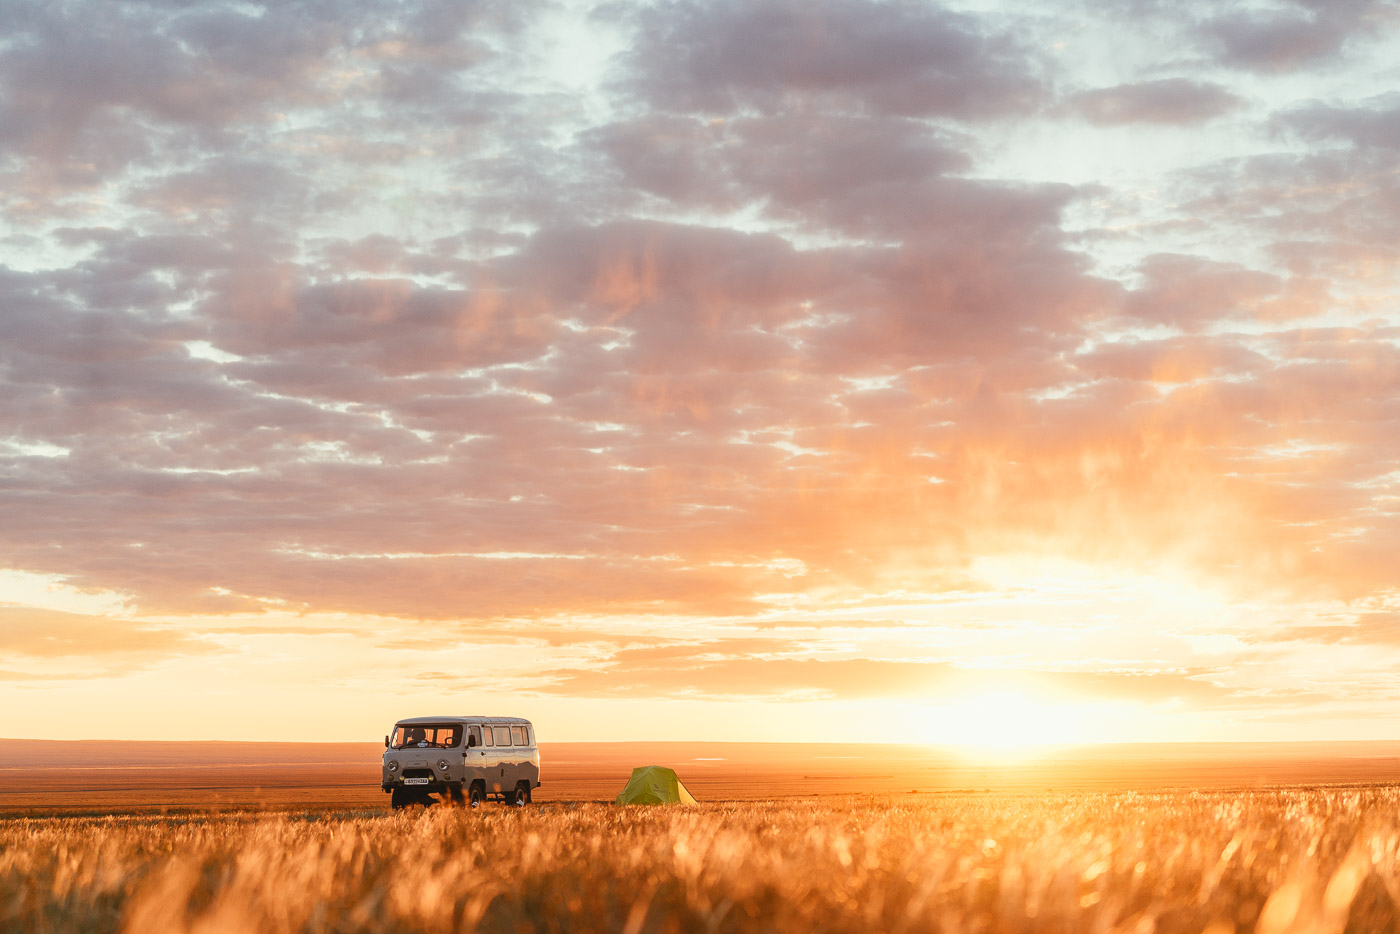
(379, 717, 539, 808)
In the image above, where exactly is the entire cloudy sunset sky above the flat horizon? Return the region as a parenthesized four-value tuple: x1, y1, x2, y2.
(0, 0, 1400, 745)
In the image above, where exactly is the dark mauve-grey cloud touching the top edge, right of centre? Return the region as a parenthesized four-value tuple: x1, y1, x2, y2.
(620, 0, 1044, 120)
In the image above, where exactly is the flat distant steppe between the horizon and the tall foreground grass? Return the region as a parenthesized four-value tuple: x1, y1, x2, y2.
(0, 739, 1400, 816)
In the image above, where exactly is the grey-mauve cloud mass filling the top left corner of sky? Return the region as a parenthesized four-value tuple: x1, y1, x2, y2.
(0, 0, 538, 217)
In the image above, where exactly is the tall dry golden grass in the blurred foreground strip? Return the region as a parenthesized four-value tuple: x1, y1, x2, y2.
(0, 788, 1400, 934)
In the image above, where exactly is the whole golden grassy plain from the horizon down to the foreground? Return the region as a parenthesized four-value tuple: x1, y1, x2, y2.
(0, 739, 1400, 934)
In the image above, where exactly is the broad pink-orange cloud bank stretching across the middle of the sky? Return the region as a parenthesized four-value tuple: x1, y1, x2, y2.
(0, 205, 1385, 619)
